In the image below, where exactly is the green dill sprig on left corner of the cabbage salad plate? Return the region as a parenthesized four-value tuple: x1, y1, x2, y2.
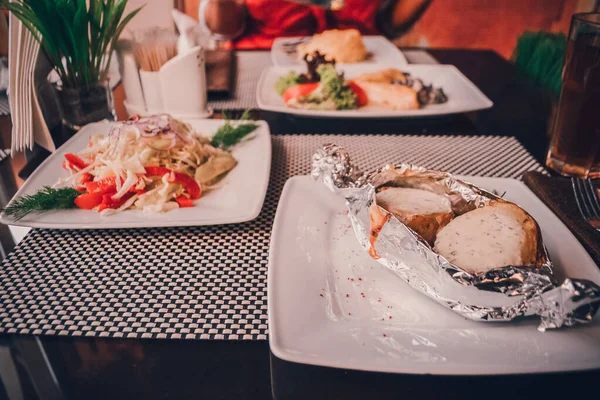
(2, 186, 81, 221)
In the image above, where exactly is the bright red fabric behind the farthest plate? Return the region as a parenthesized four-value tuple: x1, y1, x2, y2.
(233, 0, 381, 49)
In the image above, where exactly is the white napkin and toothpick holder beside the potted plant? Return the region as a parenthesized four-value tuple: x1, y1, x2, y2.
(119, 43, 212, 119)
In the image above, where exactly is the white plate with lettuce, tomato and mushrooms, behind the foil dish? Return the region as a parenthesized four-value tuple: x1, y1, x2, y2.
(256, 64, 494, 118)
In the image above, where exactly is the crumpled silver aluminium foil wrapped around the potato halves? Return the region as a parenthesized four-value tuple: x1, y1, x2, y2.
(312, 144, 600, 331)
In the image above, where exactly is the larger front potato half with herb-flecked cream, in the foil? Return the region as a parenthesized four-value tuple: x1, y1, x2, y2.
(434, 201, 541, 274)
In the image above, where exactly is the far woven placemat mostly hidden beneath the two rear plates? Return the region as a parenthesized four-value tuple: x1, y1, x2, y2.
(208, 50, 438, 110)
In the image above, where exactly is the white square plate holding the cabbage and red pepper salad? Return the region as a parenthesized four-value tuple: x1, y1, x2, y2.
(0, 120, 271, 229)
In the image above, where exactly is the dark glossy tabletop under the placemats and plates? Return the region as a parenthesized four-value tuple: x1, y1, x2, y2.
(0, 50, 600, 400)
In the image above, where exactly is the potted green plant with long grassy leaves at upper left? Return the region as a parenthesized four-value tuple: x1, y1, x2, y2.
(0, 0, 141, 129)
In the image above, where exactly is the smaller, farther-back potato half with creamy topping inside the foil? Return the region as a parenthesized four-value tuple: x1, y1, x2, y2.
(376, 187, 454, 245)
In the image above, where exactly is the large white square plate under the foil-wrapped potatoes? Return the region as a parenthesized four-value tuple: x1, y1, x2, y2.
(268, 177, 600, 375)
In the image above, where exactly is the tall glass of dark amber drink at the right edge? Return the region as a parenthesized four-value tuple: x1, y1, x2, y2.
(546, 13, 600, 178)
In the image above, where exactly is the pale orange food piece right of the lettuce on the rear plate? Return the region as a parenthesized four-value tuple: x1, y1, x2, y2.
(353, 79, 419, 110)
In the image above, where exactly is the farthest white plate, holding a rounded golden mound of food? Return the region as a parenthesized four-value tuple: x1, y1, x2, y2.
(271, 36, 408, 66)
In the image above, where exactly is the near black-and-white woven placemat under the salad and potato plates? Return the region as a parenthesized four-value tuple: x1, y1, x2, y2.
(0, 135, 542, 340)
